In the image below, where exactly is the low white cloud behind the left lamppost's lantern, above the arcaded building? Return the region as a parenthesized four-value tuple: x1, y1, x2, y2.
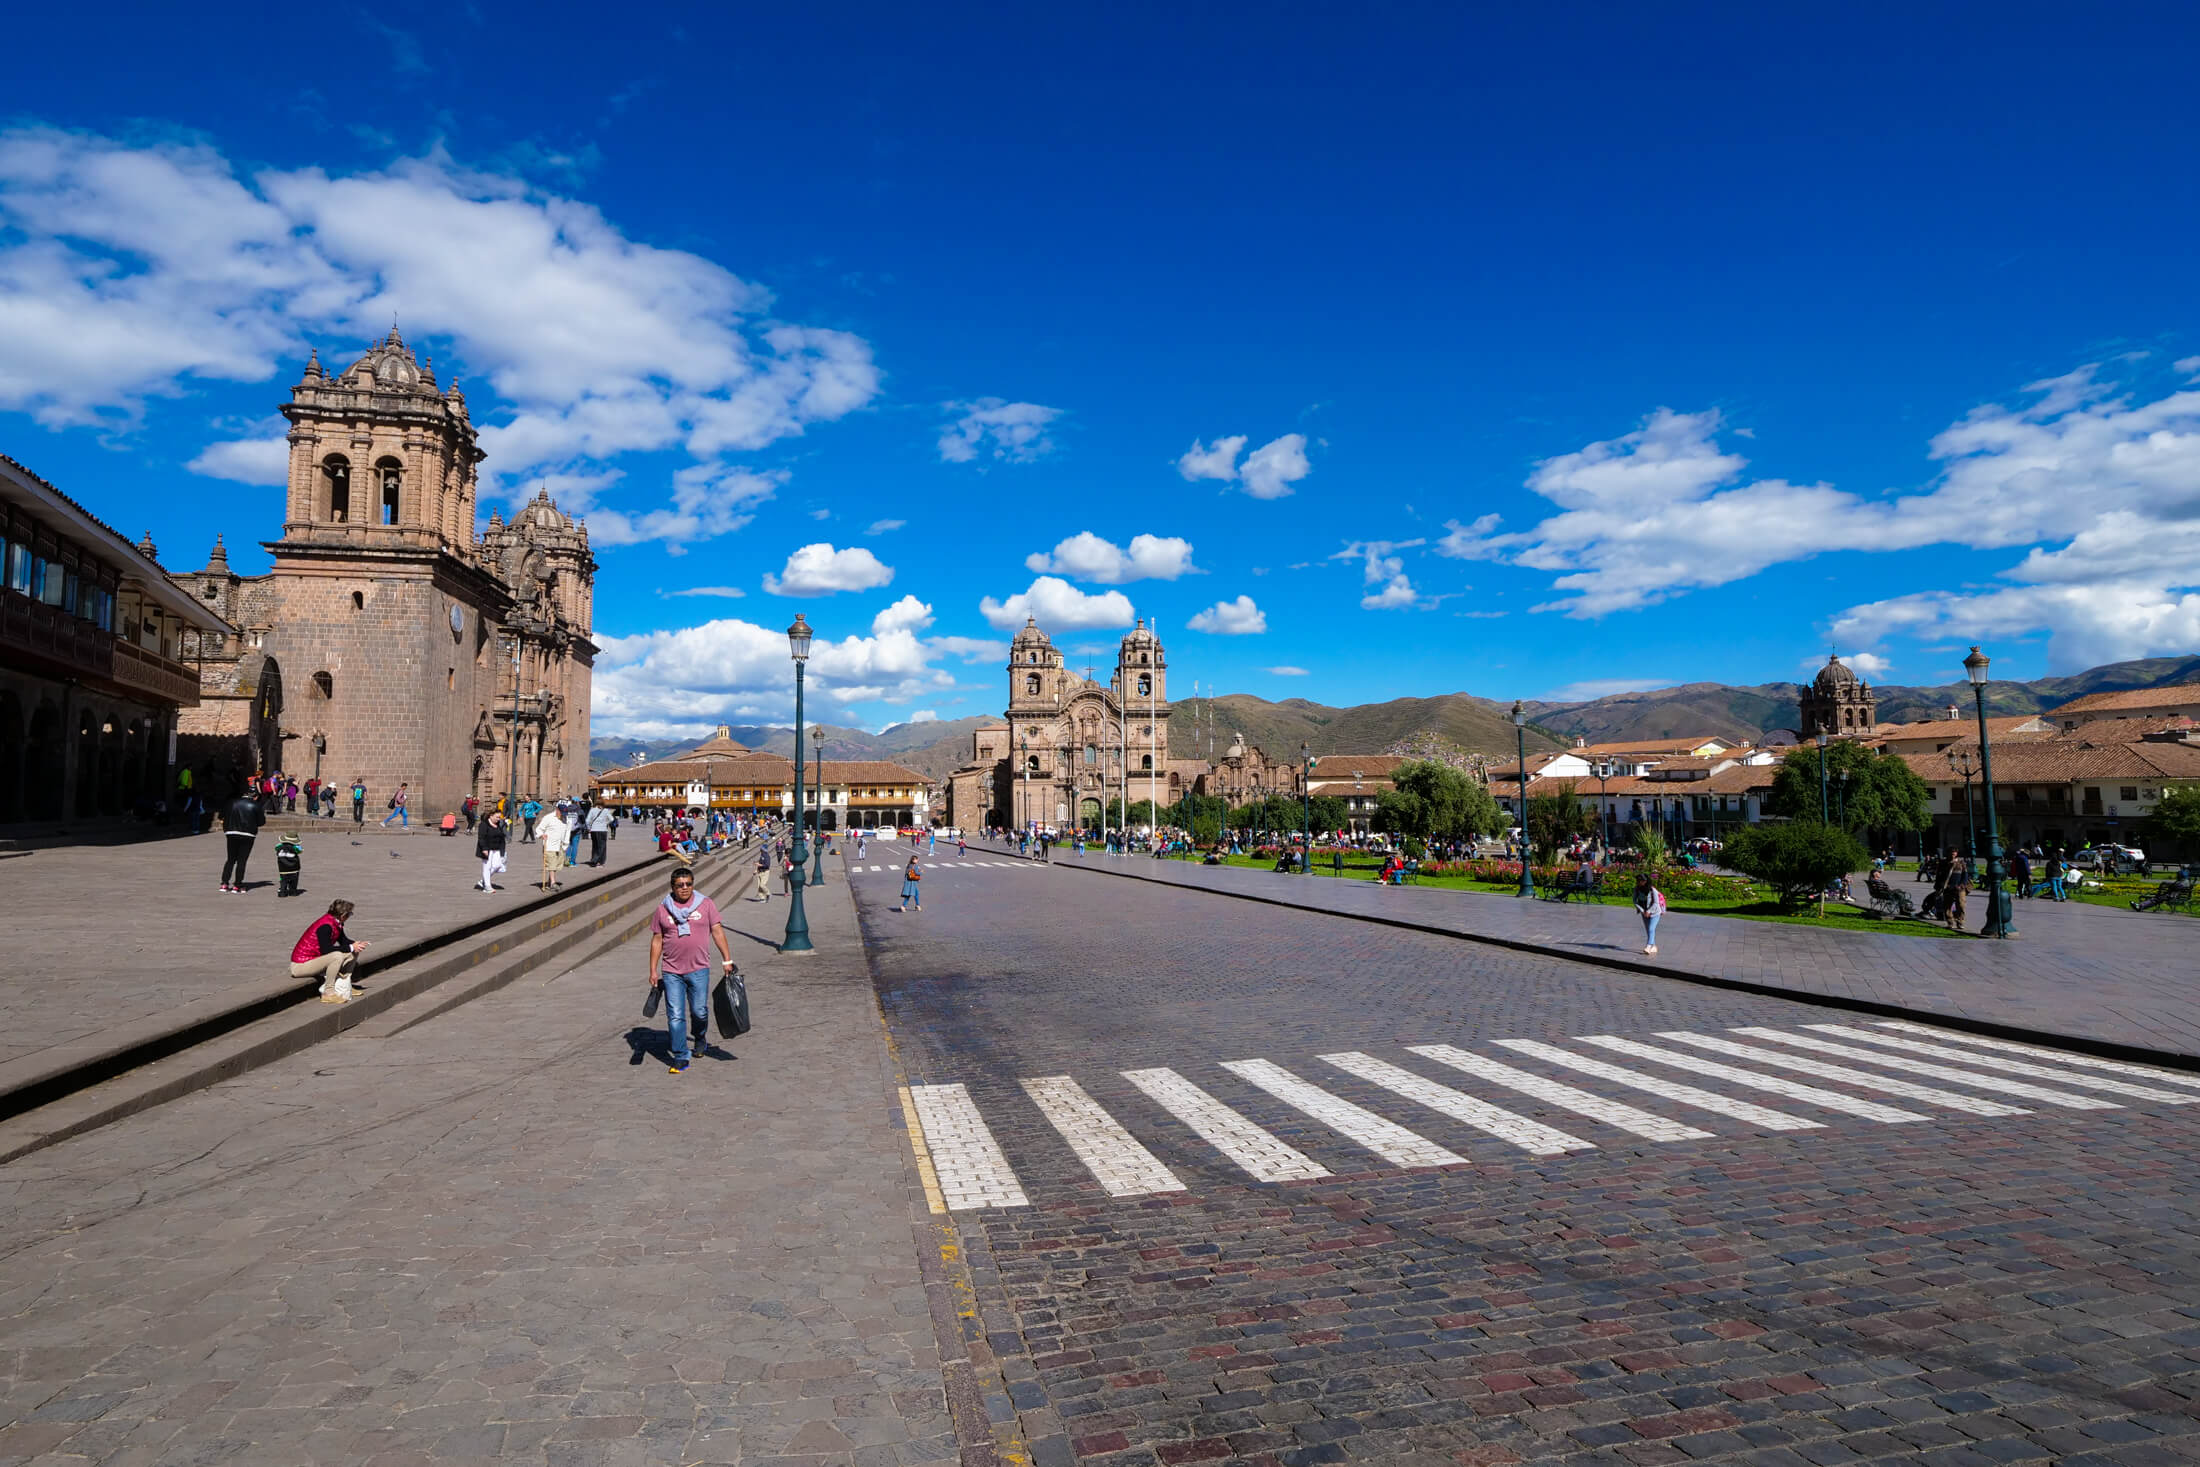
(592, 618, 955, 735)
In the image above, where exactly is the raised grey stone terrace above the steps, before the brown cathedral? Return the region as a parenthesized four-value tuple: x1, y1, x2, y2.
(0, 823, 658, 1062)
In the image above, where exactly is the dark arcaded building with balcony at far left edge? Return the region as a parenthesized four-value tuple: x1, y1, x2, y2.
(0, 457, 231, 825)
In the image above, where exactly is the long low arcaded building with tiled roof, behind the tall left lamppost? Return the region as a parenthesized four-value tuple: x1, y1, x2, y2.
(594, 724, 931, 831)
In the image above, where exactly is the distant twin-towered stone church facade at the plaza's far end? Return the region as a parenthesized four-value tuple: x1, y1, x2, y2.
(946, 618, 1208, 831)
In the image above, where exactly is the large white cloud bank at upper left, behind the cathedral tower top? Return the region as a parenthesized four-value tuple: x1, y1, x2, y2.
(0, 128, 878, 543)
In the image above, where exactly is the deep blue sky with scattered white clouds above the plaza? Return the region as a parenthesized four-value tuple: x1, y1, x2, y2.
(0, 2, 2200, 732)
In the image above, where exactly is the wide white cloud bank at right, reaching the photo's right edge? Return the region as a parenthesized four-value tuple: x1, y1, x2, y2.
(1437, 365, 2200, 671)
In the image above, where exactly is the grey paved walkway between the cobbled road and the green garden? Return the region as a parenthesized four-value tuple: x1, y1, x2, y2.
(1058, 856, 2200, 1058)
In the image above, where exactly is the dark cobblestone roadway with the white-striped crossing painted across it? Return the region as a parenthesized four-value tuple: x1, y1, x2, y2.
(851, 851, 2200, 1467)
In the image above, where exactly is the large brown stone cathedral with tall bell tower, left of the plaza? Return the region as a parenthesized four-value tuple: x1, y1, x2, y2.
(169, 328, 596, 823)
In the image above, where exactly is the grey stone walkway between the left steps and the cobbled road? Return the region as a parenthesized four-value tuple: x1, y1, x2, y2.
(0, 842, 957, 1467)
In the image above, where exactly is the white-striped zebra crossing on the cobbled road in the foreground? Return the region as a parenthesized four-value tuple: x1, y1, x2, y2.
(902, 1021, 2200, 1212)
